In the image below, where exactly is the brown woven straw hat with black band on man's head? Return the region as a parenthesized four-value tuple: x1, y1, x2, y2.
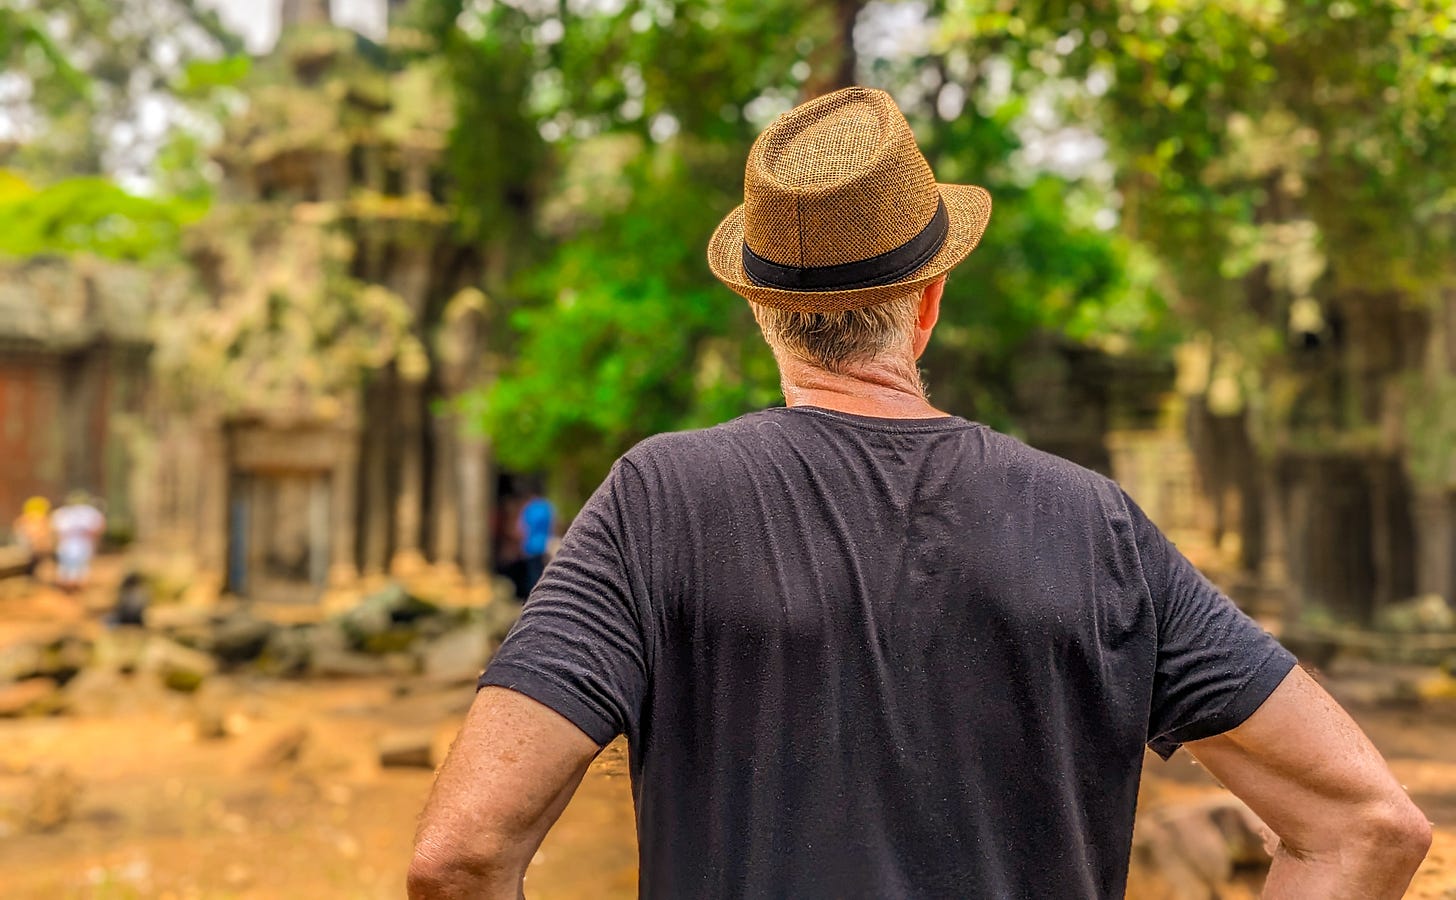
(708, 87, 992, 313)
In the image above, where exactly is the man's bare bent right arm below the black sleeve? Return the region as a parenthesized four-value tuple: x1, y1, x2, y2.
(1187, 666, 1431, 900)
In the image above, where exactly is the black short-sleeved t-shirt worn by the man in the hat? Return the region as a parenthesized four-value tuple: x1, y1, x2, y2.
(480, 408, 1294, 900)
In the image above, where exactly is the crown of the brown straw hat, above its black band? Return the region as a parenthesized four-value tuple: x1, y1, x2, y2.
(744, 87, 941, 267)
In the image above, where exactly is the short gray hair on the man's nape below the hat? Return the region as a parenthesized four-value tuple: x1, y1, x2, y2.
(751, 291, 920, 374)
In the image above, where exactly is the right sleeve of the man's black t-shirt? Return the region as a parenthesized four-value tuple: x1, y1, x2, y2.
(1125, 489, 1296, 759)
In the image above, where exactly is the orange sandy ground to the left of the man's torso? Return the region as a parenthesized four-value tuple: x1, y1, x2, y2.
(0, 679, 636, 900)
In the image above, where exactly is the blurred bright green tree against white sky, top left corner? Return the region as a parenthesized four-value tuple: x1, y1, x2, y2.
(0, 0, 246, 259)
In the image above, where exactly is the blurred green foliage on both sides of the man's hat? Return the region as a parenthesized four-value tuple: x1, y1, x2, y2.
(418, 0, 1166, 485)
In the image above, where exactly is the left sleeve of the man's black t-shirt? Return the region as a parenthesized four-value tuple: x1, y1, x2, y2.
(479, 462, 646, 744)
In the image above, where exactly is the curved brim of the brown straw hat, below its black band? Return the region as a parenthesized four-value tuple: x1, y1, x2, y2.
(708, 185, 992, 313)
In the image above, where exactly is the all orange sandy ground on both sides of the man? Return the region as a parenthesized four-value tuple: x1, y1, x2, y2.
(0, 570, 1456, 900)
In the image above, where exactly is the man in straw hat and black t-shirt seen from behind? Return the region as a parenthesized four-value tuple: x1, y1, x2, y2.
(409, 89, 1430, 900)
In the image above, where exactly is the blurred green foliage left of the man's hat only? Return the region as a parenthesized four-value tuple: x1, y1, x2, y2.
(418, 1, 844, 486)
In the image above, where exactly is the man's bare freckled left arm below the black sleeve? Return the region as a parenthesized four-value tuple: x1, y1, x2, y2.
(409, 686, 600, 900)
